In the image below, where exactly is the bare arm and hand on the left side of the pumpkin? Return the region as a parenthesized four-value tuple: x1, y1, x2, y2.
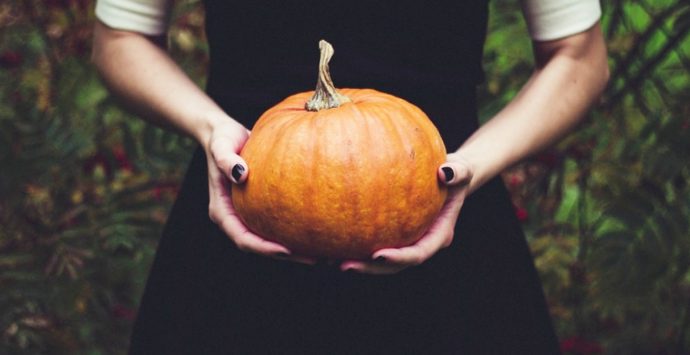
(92, 21, 313, 263)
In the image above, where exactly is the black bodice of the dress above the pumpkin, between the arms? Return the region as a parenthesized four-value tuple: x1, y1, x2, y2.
(205, 0, 487, 149)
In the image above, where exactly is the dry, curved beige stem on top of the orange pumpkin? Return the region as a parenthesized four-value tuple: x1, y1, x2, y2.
(305, 40, 351, 111)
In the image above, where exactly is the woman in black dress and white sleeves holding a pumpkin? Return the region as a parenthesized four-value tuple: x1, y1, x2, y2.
(93, 0, 608, 354)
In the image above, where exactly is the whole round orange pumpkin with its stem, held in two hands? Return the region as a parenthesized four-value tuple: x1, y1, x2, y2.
(232, 41, 447, 259)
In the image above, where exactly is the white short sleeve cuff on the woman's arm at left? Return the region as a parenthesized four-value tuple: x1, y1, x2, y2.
(96, 0, 172, 36)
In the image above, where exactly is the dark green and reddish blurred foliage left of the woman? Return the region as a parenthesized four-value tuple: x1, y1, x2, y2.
(0, 0, 203, 354)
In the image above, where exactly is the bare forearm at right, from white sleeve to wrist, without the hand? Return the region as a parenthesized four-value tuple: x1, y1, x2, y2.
(458, 25, 608, 190)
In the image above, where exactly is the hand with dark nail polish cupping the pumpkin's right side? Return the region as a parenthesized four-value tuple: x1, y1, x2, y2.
(340, 153, 472, 274)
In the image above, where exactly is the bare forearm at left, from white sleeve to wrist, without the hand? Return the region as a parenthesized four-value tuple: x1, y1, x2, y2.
(92, 23, 240, 144)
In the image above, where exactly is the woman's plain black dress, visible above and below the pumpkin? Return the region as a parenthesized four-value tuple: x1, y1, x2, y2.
(131, 0, 559, 354)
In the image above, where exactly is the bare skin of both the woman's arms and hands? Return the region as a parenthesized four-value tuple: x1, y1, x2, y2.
(92, 14, 609, 274)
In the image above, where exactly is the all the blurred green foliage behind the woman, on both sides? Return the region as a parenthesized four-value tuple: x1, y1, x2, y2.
(0, 0, 690, 354)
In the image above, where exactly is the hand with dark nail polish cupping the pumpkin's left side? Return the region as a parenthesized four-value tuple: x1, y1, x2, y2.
(204, 118, 315, 264)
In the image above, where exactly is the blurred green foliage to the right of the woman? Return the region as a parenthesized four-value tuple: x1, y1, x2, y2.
(484, 0, 690, 354)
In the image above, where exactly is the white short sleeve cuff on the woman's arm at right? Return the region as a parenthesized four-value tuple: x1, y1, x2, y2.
(520, 0, 601, 41)
